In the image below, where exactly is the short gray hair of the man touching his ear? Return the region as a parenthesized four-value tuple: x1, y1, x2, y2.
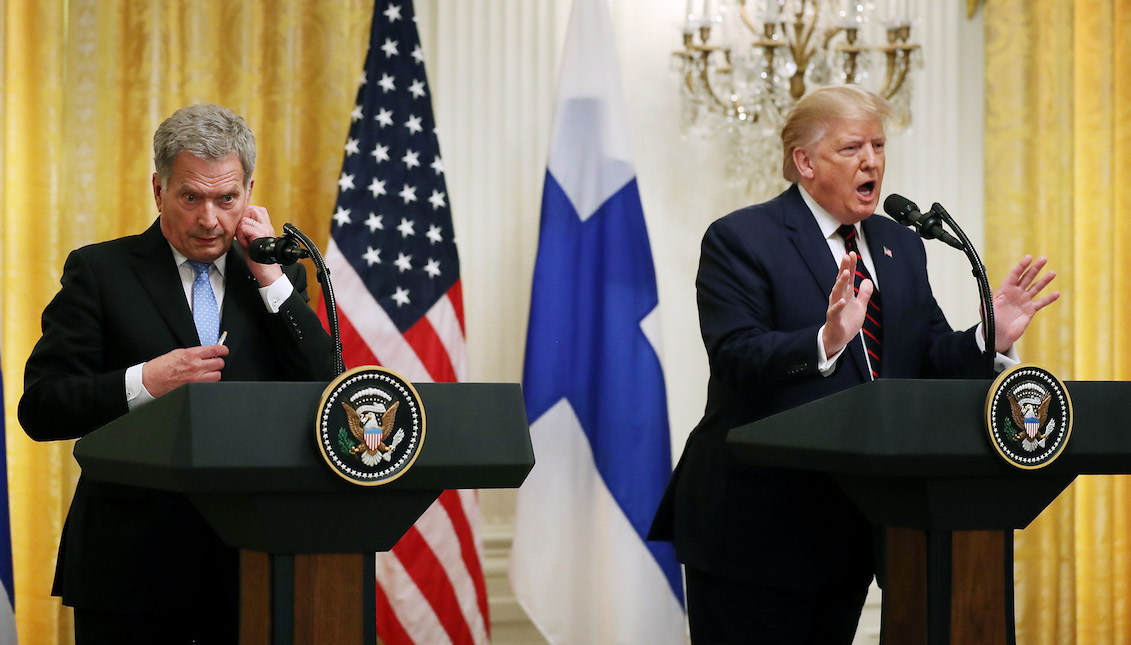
(153, 103, 256, 188)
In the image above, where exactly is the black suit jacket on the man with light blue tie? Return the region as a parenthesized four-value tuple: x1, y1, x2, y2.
(19, 222, 334, 612)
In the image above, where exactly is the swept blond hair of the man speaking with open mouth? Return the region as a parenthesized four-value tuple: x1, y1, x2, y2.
(782, 85, 891, 183)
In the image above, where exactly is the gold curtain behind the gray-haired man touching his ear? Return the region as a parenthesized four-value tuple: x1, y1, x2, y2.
(0, 0, 373, 644)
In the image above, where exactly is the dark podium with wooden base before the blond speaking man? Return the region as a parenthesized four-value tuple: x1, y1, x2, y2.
(727, 379, 1131, 645)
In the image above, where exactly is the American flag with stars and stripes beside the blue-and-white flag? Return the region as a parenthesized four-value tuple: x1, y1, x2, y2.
(323, 0, 490, 645)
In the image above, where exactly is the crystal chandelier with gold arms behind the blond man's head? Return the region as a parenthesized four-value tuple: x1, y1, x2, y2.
(673, 0, 922, 197)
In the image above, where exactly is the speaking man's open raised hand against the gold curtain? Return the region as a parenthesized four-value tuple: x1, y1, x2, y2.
(993, 256, 1060, 353)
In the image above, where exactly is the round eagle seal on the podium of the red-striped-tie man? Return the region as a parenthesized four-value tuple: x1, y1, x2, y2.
(986, 364, 1072, 470)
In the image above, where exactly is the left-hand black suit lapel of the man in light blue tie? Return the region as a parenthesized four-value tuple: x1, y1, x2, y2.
(132, 220, 200, 347)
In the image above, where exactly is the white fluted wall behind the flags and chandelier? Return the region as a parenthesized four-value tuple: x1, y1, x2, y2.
(415, 0, 981, 643)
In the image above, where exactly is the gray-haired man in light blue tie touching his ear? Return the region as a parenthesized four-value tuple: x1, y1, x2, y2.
(19, 105, 335, 645)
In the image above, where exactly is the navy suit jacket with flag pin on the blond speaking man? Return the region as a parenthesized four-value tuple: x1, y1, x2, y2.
(651, 186, 985, 590)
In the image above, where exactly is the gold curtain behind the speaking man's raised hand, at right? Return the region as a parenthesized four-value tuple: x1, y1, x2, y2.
(984, 0, 1131, 645)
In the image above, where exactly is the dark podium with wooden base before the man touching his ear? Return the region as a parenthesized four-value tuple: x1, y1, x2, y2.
(75, 382, 534, 645)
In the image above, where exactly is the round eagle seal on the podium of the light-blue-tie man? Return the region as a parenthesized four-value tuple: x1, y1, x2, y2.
(314, 366, 424, 485)
